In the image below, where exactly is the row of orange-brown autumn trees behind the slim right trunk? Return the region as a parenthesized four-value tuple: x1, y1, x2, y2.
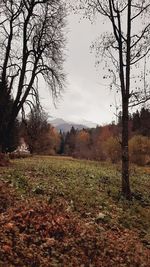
(61, 108, 150, 165)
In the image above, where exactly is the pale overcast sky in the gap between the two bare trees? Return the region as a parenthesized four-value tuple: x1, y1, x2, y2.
(42, 14, 115, 124)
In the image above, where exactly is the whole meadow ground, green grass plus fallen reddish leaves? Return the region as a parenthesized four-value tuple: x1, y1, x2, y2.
(0, 156, 150, 267)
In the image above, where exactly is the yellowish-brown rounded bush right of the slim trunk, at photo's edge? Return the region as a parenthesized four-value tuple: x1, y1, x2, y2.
(129, 135, 150, 166)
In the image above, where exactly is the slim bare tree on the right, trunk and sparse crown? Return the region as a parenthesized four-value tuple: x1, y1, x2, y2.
(79, 0, 150, 199)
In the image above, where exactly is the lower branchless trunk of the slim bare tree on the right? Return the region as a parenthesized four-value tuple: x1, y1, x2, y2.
(122, 99, 131, 200)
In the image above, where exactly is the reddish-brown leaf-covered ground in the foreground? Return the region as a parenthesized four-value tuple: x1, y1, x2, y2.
(0, 180, 150, 267)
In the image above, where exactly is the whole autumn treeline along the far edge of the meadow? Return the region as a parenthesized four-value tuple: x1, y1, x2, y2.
(9, 108, 150, 165)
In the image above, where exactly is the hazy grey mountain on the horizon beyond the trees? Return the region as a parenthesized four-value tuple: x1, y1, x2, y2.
(50, 118, 96, 132)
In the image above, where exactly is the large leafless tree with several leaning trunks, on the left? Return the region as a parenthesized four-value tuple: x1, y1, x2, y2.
(0, 0, 66, 151)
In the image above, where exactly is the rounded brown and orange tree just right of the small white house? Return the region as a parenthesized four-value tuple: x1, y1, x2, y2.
(21, 106, 60, 154)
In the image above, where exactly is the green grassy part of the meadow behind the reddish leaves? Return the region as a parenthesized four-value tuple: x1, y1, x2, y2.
(0, 156, 150, 238)
